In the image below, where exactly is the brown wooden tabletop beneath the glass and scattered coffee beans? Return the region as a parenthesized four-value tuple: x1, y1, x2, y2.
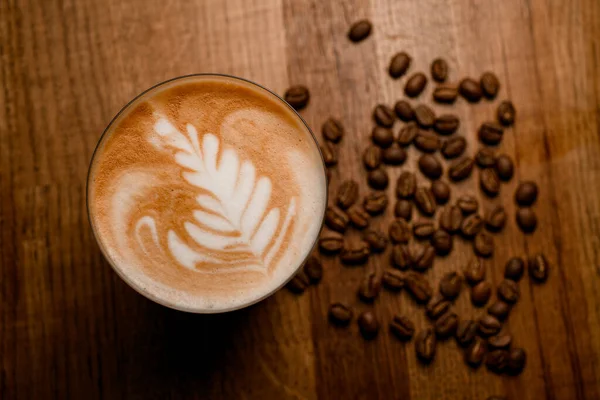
(0, 0, 600, 400)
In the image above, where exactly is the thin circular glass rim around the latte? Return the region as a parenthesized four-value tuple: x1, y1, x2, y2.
(85, 72, 329, 314)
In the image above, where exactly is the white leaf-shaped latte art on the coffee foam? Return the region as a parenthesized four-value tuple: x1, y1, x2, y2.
(137, 117, 296, 273)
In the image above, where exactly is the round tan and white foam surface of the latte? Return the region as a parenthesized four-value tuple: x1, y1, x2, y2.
(88, 76, 326, 312)
